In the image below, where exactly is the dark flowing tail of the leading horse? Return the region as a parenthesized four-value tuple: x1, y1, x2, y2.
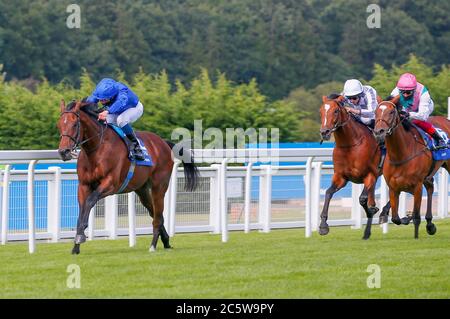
(166, 140, 200, 192)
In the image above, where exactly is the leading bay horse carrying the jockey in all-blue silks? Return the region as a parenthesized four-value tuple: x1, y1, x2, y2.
(58, 100, 199, 254)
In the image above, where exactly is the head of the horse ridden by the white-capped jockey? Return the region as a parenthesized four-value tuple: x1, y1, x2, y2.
(320, 95, 346, 141)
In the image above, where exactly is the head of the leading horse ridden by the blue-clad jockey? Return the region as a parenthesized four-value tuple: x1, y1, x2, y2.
(58, 100, 81, 161)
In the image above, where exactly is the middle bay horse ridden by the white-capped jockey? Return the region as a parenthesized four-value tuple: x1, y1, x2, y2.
(319, 94, 390, 239)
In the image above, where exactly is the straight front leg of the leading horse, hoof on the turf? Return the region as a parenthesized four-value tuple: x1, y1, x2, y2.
(72, 183, 100, 254)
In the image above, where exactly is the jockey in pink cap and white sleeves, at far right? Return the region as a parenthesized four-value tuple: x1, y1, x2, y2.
(391, 73, 447, 149)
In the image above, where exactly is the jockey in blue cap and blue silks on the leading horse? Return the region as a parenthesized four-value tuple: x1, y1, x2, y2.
(86, 78, 145, 161)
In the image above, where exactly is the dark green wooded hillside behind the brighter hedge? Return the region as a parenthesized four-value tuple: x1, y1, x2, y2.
(0, 0, 450, 100)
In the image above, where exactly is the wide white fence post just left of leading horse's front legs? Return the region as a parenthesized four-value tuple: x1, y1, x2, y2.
(47, 166, 61, 243)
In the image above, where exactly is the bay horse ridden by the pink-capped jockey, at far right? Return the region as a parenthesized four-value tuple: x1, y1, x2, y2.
(374, 96, 450, 238)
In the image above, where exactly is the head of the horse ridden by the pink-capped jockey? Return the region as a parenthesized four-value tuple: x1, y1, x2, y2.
(373, 96, 401, 142)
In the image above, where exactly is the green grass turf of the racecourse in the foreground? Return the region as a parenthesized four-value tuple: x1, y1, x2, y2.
(0, 219, 450, 298)
